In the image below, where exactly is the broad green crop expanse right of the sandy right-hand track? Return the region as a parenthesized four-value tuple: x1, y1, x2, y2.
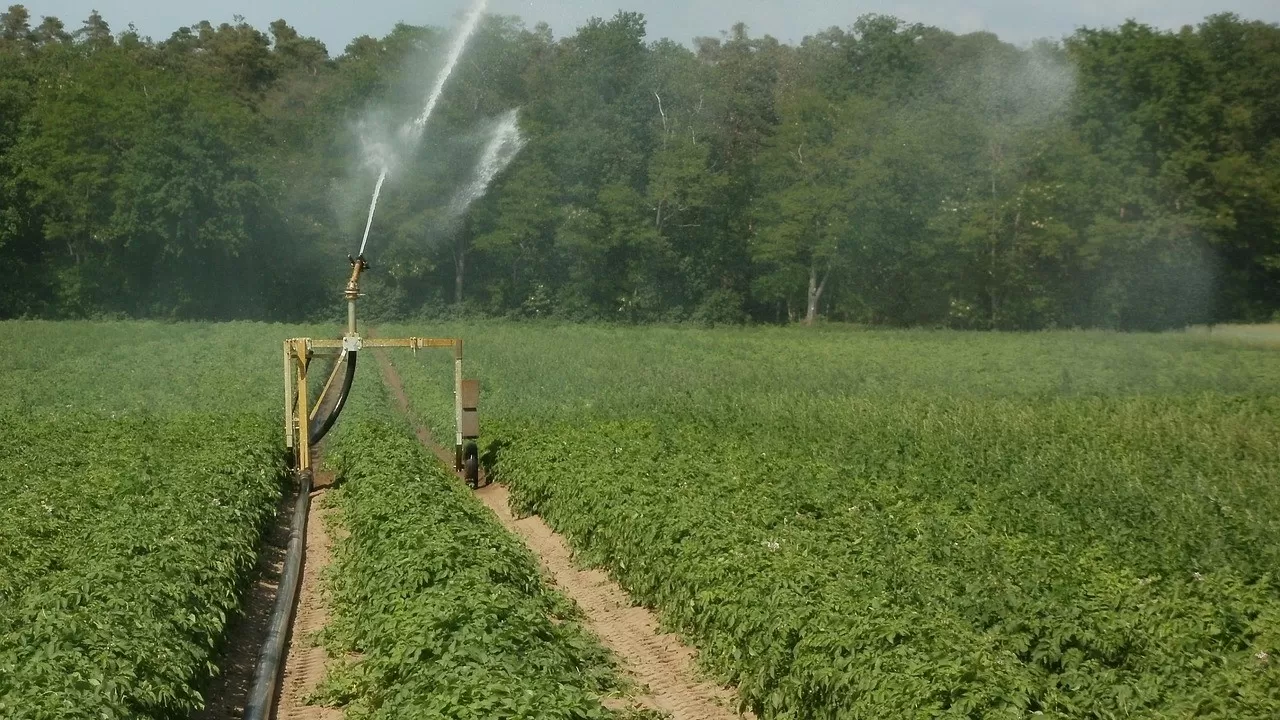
(386, 324, 1280, 719)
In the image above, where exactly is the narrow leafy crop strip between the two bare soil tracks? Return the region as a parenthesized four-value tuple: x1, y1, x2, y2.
(320, 409, 645, 720)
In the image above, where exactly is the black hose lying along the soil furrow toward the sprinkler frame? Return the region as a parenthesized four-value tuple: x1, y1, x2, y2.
(244, 470, 311, 720)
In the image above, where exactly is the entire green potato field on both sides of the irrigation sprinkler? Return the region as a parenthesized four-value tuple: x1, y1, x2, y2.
(0, 322, 1280, 719)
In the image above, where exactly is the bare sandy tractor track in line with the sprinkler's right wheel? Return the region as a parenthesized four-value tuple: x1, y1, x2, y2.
(375, 351, 754, 720)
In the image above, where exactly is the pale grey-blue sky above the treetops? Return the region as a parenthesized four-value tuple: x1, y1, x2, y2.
(22, 0, 1280, 55)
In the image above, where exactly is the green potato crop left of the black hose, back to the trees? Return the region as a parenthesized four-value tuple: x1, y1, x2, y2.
(0, 322, 313, 719)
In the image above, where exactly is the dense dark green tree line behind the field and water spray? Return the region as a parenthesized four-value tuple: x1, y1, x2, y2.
(0, 5, 1280, 329)
